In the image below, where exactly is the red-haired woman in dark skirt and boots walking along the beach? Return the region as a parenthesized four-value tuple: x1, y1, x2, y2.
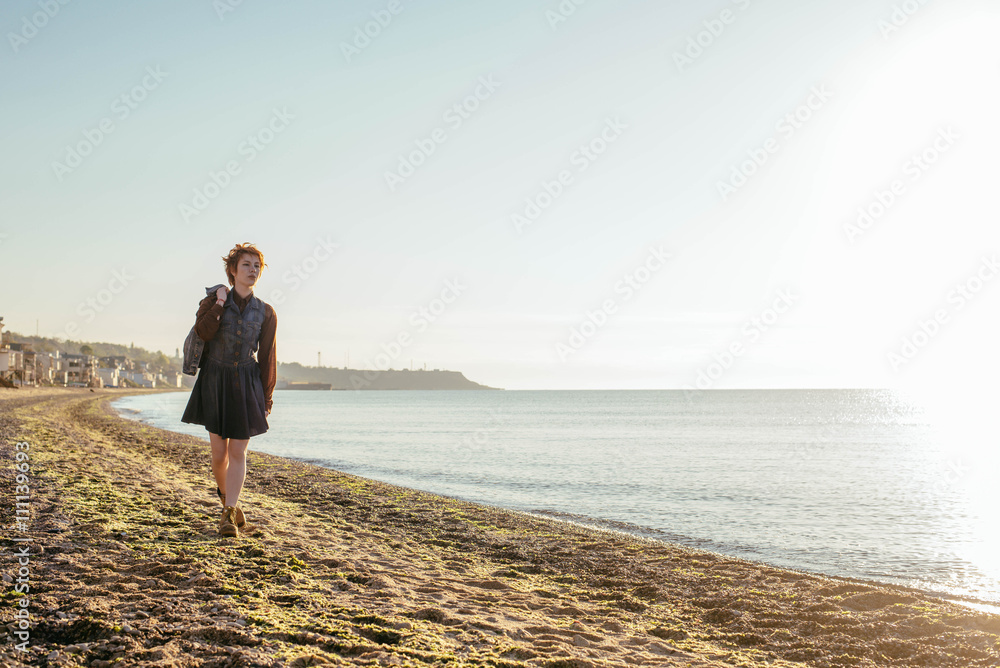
(181, 243, 278, 537)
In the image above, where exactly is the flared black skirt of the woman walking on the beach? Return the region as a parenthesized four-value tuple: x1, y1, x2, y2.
(181, 357, 267, 440)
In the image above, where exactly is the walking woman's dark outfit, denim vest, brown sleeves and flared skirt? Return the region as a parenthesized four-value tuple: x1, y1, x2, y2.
(181, 290, 276, 440)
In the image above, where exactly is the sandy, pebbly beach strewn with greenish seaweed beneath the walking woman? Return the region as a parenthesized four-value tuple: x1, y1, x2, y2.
(0, 388, 1000, 668)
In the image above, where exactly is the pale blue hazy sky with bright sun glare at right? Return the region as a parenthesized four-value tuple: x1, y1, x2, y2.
(0, 0, 1000, 393)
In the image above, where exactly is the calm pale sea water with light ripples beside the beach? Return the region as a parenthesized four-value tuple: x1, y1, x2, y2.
(113, 390, 1000, 605)
